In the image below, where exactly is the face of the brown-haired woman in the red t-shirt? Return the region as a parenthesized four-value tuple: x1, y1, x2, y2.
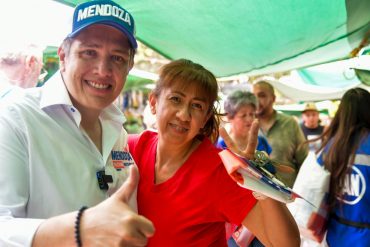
(149, 82, 210, 145)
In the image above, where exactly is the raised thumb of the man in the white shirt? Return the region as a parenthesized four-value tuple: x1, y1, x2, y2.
(114, 165, 139, 203)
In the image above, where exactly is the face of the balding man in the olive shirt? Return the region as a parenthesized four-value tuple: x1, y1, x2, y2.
(253, 84, 275, 117)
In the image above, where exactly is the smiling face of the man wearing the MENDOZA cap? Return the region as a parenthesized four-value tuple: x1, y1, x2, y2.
(59, 24, 133, 112)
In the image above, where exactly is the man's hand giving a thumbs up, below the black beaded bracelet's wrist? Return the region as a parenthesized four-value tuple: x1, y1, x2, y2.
(80, 166, 154, 246)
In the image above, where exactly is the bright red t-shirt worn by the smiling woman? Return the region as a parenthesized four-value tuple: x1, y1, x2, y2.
(128, 131, 256, 247)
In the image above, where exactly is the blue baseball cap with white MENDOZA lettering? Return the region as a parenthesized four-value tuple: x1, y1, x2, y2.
(68, 0, 137, 49)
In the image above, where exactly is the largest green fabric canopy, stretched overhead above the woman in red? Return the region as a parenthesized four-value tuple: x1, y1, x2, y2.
(59, 0, 370, 77)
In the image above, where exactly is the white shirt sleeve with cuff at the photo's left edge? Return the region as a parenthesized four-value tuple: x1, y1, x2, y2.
(0, 107, 42, 246)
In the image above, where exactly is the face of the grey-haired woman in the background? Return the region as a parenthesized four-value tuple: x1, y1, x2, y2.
(229, 105, 256, 136)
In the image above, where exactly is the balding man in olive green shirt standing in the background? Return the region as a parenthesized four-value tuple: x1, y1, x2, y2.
(253, 80, 308, 187)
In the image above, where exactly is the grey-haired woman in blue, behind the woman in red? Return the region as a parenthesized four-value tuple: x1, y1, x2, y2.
(217, 90, 271, 247)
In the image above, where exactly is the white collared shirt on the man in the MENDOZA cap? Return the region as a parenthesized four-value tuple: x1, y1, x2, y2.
(0, 72, 137, 246)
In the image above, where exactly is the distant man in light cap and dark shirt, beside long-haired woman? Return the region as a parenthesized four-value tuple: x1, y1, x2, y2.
(301, 102, 324, 151)
